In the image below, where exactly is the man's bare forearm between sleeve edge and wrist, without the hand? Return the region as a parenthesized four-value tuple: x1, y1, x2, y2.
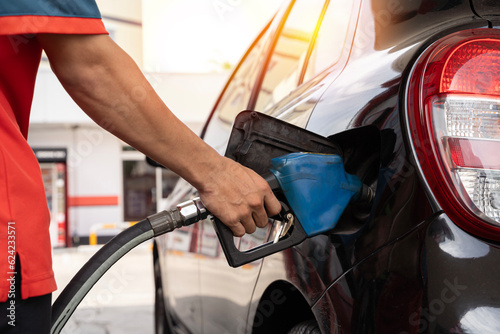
(39, 35, 219, 188)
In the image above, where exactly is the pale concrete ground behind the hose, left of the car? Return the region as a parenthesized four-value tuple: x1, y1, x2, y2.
(53, 242, 154, 334)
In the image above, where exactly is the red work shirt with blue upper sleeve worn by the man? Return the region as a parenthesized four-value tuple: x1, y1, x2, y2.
(0, 0, 107, 302)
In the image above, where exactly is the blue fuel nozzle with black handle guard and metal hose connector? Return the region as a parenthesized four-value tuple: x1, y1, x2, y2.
(148, 153, 374, 267)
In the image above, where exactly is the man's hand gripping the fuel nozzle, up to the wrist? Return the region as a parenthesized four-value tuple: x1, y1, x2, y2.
(198, 157, 281, 236)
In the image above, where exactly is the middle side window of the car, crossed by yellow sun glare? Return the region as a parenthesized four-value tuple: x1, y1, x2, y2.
(255, 0, 325, 111)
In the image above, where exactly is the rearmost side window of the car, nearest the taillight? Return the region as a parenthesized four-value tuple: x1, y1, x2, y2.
(304, 0, 355, 81)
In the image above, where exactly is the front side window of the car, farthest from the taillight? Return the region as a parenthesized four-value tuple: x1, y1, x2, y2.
(215, 24, 276, 123)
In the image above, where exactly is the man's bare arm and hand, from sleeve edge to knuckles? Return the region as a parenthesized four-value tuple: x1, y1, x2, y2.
(38, 34, 280, 236)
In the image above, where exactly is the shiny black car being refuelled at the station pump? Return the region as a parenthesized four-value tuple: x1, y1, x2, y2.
(153, 0, 500, 334)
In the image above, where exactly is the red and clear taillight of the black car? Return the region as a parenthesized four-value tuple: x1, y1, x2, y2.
(407, 29, 500, 240)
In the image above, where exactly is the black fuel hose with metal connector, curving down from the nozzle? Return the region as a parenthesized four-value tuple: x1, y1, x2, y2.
(50, 198, 209, 334)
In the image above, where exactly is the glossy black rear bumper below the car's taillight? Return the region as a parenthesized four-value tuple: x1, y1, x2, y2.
(313, 213, 500, 333)
